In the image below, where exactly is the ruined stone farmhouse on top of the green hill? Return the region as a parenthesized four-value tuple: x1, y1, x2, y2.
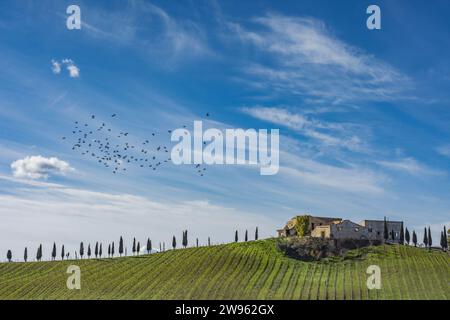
(277, 215, 403, 242)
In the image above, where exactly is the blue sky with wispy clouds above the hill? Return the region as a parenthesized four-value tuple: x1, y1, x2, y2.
(0, 0, 450, 258)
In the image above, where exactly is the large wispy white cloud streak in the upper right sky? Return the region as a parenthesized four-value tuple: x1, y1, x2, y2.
(228, 15, 410, 103)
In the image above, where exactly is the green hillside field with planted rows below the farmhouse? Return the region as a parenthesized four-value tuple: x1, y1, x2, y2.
(0, 240, 450, 300)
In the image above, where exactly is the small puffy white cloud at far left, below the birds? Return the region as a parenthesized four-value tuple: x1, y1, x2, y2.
(11, 156, 73, 179)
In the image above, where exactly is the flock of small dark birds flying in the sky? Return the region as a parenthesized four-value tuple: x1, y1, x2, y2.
(62, 113, 210, 176)
